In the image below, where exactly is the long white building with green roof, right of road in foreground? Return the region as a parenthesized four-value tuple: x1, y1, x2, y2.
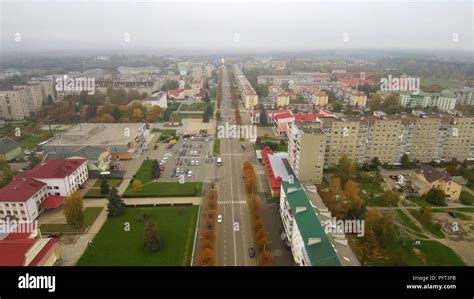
(280, 180, 341, 266)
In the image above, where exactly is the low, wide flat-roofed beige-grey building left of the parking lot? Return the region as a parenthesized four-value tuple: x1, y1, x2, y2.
(43, 123, 149, 159)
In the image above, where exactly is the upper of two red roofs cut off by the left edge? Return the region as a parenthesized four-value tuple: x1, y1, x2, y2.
(0, 178, 46, 202)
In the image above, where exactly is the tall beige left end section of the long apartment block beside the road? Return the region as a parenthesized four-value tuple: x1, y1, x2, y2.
(287, 122, 326, 183)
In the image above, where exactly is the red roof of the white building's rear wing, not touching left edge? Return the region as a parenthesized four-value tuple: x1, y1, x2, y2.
(26, 159, 86, 179)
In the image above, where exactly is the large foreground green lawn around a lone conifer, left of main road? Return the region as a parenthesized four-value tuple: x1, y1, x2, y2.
(77, 206, 199, 266)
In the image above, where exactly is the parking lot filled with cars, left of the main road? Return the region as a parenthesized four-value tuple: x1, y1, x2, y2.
(159, 135, 214, 182)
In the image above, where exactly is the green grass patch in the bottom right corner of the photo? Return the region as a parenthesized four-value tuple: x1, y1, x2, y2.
(375, 240, 465, 266)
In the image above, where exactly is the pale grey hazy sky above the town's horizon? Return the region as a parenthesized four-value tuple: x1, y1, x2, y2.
(0, 0, 474, 51)
